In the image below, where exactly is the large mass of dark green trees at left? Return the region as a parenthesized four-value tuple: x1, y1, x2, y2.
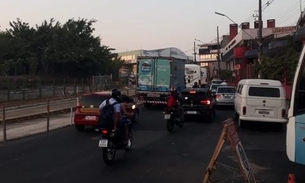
(0, 19, 122, 78)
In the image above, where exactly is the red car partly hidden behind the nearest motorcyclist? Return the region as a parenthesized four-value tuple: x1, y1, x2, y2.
(74, 91, 139, 131)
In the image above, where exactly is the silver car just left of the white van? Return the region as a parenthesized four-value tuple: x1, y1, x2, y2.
(215, 86, 235, 106)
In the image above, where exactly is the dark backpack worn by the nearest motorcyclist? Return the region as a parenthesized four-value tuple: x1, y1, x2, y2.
(99, 99, 118, 128)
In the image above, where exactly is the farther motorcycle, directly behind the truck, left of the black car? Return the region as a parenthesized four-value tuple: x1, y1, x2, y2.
(163, 104, 184, 133)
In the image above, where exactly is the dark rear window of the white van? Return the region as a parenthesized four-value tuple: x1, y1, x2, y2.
(249, 87, 280, 98)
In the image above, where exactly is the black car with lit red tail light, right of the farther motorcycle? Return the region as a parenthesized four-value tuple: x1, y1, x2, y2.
(181, 88, 215, 122)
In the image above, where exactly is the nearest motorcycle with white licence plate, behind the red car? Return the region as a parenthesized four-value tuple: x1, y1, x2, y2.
(98, 116, 133, 165)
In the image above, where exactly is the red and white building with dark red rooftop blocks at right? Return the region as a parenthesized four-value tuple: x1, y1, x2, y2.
(221, 19, 297, 84)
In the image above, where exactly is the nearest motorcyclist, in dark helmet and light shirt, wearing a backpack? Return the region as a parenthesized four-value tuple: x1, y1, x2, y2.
(99, 88, 133, 145)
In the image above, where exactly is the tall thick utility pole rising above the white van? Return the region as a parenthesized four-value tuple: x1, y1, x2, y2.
(257, 0, 263, 79)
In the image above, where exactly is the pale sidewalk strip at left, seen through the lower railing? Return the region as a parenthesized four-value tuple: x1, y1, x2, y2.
(0, 113, 74, 144)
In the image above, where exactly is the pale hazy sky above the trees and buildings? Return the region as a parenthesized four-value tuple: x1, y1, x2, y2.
(0, 0, 305, 55)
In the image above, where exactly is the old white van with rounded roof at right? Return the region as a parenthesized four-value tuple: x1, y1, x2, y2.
(234, 79, 287, 127)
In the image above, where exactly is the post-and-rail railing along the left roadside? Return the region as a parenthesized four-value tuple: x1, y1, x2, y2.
(0, 88, 136, 143)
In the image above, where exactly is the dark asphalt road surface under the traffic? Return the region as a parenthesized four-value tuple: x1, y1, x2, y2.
(0, 106, 305, 183)
